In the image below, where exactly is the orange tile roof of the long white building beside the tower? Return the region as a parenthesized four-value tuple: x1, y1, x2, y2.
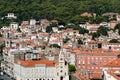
(15, 60, 55, 67)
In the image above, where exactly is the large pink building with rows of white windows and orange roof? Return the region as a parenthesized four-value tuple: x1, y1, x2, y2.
(76, 51, 119, 73)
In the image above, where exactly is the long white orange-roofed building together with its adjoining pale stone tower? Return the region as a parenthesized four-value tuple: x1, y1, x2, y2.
(13, 53, 69, 80)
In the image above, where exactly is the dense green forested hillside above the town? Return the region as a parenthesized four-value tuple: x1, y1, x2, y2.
(0, 0, 120, 21)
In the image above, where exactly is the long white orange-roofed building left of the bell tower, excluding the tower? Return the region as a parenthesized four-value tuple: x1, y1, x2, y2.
(14, 60, 57, 80)
